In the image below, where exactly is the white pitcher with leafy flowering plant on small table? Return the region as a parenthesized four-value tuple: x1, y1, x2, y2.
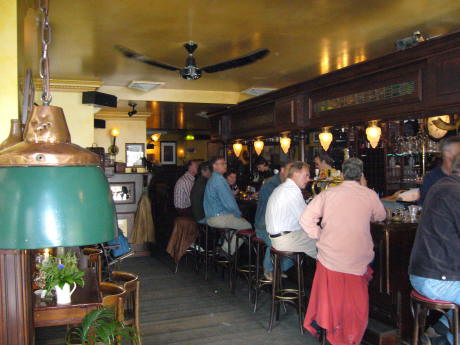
(39, 253, 85, 304)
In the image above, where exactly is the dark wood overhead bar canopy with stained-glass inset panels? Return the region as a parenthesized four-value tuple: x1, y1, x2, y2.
(211, 32, 460, 140)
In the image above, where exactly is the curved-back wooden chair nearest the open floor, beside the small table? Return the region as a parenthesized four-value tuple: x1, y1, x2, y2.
(112, 271, 142, 345)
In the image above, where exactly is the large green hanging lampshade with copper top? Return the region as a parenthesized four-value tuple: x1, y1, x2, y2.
(0, 106, 117, 249)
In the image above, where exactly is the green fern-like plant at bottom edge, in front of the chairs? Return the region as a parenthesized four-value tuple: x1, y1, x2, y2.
(66, 307, 137, 345)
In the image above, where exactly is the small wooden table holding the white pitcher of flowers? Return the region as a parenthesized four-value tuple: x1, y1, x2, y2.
(33, 269, 102, 327)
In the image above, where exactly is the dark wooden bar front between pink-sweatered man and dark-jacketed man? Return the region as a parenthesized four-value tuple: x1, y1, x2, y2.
(364, 222, 417, 345)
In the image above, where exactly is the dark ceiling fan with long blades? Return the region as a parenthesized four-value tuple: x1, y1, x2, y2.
(115, 41, 270, 80)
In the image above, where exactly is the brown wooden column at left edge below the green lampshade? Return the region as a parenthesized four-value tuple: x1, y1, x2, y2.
(0, 249, 34, 345)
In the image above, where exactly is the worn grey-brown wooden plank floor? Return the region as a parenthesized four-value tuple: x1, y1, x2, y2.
(36, 251, 318, 345)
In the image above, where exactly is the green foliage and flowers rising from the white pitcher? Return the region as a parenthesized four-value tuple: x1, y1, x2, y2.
(39, 253, 85, 291)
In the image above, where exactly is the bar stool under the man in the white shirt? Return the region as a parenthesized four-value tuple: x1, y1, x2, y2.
(268, 247, 305, 334)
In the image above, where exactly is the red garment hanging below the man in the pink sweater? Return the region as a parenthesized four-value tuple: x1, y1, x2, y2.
(303, 261, 372, 345)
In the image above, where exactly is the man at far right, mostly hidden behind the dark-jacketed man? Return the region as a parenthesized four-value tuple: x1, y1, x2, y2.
(419, 136, 460, 205)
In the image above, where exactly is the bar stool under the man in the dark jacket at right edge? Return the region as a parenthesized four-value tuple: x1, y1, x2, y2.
(410, 290, 458, 345)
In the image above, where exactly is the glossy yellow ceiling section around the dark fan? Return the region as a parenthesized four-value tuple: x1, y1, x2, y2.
(45, 0, 460, 98)
